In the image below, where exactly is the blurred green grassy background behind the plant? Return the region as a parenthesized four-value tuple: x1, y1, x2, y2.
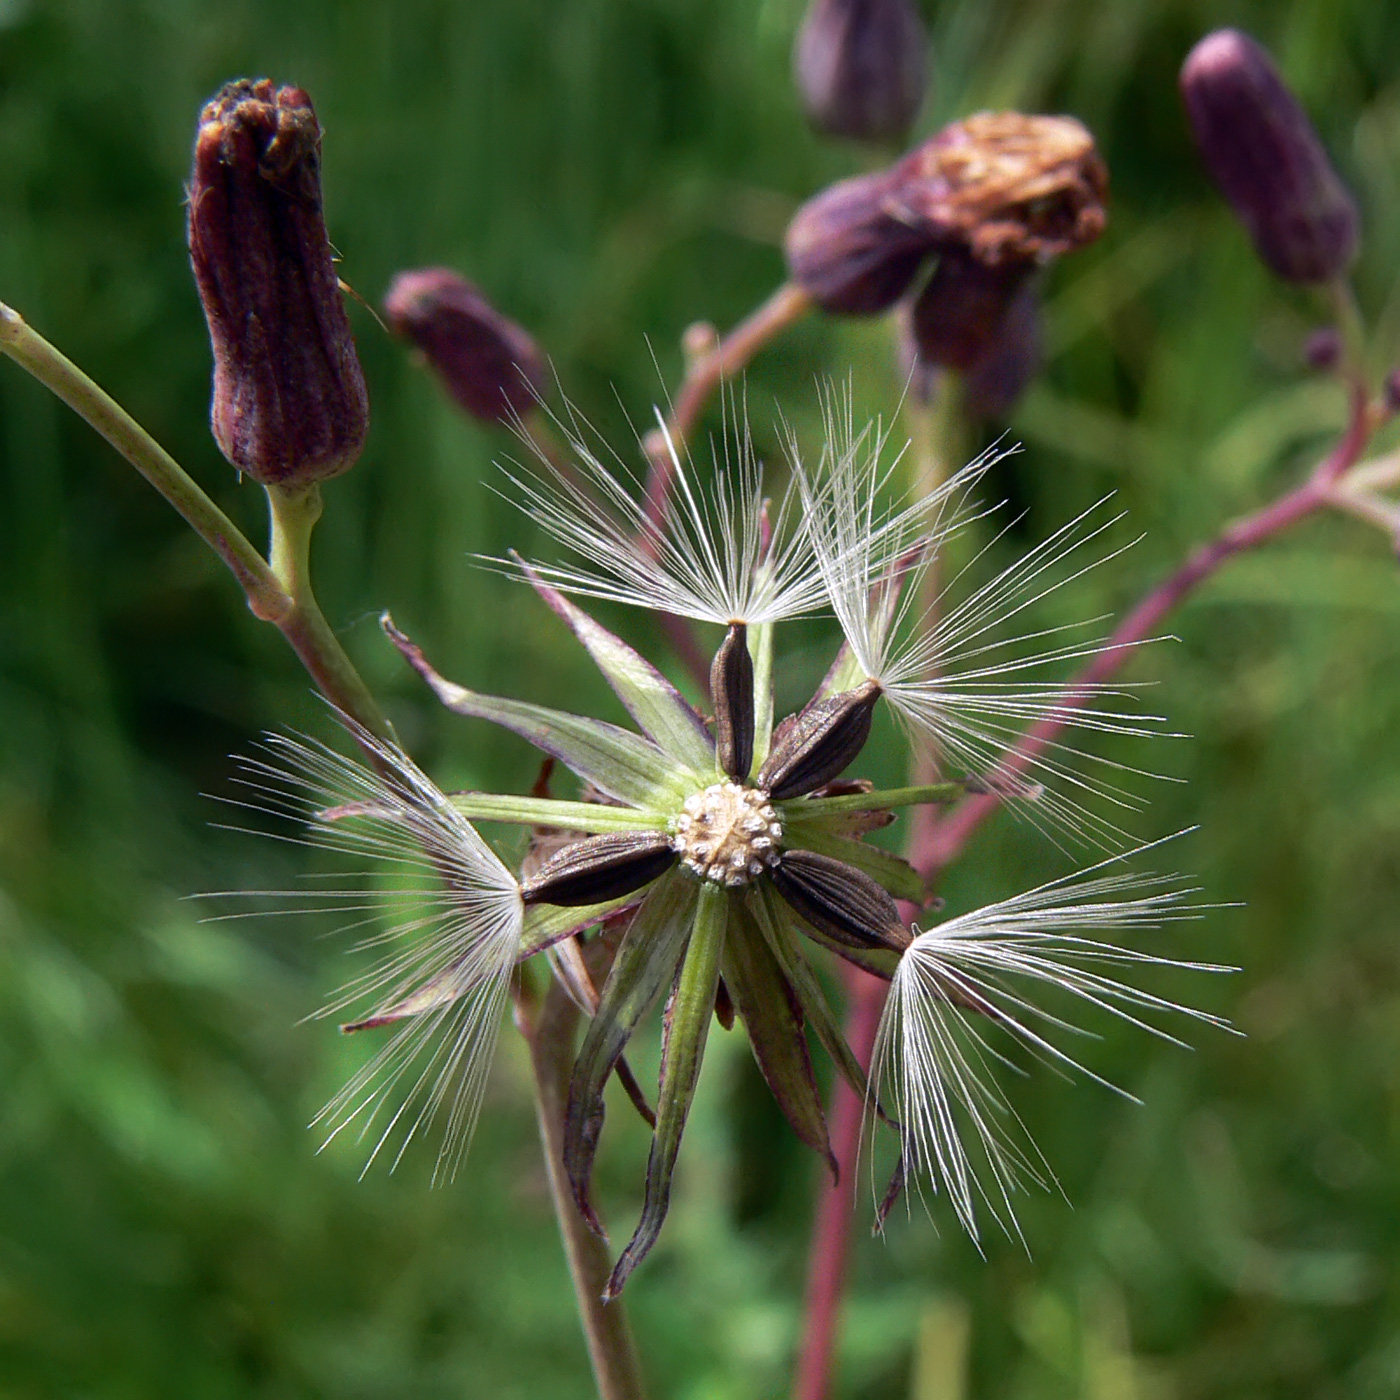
(0, 0, 1400, 1400)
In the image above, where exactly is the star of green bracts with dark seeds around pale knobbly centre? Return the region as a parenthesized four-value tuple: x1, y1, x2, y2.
(384, 560, 965, 1295)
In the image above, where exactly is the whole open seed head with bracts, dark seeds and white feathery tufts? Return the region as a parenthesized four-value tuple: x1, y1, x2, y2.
(238, 399, 1226, 1298)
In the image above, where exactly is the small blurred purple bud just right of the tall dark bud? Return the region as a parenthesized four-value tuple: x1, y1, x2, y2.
(384, 267, 545, 423)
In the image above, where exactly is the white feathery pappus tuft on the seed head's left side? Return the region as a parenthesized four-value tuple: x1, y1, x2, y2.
(210, 715, 524, 1180)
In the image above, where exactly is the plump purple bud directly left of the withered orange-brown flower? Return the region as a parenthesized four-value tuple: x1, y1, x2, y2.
(784, 172, 935, 316)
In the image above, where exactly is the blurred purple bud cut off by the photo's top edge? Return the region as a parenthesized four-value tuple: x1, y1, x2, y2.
(792, 0, 928, 141)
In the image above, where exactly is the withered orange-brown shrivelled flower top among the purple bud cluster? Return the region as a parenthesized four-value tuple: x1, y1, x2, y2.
(893, 112, 1109, 266)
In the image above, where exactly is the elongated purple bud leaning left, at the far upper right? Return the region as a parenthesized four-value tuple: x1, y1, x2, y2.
(1182, 29, 1358, 283)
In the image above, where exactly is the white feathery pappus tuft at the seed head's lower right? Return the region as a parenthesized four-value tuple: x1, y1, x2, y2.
(871, 833, 1233, 1240)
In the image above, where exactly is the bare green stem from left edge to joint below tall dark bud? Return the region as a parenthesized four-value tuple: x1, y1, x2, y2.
(0, 302, 291, 624)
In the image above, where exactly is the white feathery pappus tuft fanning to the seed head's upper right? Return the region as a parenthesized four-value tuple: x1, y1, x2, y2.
(801, 392, 1163, 844)
